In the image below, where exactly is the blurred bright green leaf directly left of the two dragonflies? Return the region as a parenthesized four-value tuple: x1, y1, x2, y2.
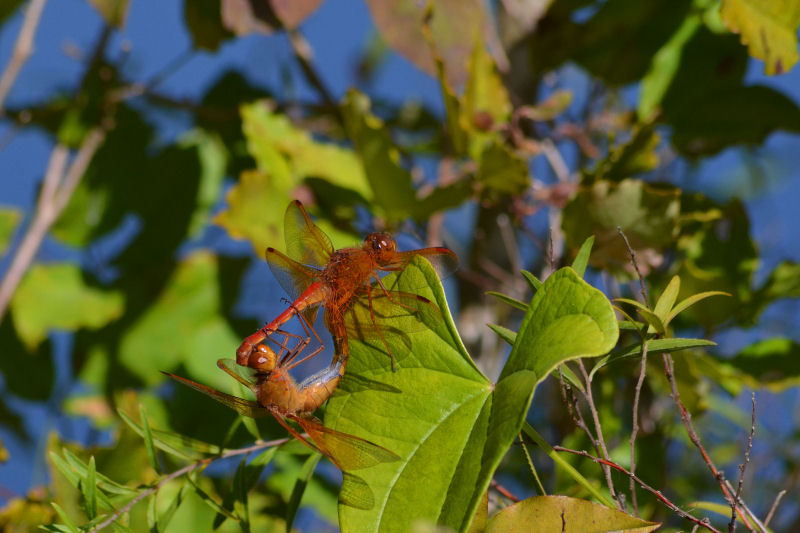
(118, 251, 239, 385)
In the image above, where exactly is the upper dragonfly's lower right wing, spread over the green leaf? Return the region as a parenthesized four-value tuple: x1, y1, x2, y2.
(345, 284, 442, 339)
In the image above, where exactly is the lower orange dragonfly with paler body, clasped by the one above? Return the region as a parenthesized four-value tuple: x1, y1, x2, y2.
(164, 325, 400, 471)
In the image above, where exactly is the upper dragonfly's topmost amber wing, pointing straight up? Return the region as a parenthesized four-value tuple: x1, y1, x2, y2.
(283, 200, 333, 268)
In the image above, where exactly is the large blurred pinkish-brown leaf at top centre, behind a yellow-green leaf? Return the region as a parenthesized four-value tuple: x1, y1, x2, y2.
(367, 0, 487, 86)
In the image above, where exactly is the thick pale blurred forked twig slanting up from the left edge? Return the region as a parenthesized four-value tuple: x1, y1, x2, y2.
(0, 126, 106, 321)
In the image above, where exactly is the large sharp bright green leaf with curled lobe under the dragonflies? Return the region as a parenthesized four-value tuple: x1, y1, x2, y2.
(325, 260, 617, 531)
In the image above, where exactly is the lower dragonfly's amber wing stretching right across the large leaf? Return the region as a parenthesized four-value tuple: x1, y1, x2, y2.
(289, 415, 400, 470)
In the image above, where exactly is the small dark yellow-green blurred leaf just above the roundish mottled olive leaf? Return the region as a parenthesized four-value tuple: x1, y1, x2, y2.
(582, 121, 661, 185)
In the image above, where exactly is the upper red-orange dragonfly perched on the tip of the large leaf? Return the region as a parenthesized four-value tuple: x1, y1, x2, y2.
(236, 200, 458, 374)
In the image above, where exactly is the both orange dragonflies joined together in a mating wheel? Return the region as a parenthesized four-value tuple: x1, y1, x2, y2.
(167, 201, 458, 470)
